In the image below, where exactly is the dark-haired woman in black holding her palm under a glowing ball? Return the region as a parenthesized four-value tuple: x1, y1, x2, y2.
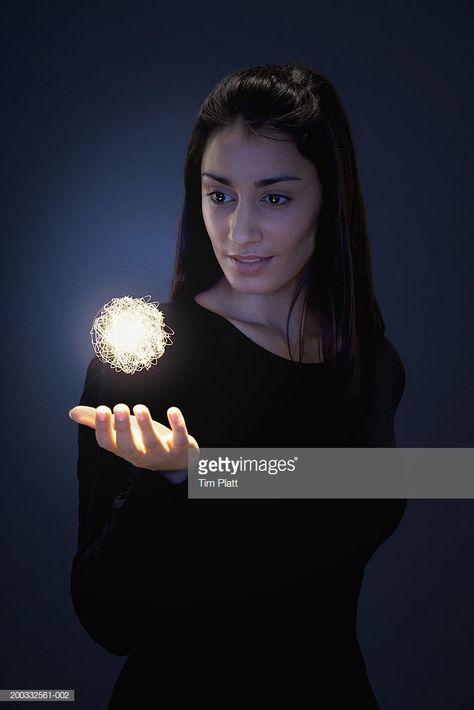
(70, 64, 406, 708)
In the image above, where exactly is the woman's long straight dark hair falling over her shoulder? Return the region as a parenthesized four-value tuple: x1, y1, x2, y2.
(171, 64, 385, 403)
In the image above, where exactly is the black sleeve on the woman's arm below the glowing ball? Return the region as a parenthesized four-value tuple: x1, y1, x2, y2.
(70, 358, 187, 655)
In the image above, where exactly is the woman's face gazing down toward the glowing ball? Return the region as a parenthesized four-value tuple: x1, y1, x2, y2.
(201, 122, 322, 294)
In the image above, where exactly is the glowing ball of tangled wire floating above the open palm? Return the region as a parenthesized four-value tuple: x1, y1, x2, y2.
(90, 296, 174, 375)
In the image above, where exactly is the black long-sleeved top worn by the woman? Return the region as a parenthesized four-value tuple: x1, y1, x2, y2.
(71, 302, 406, 708)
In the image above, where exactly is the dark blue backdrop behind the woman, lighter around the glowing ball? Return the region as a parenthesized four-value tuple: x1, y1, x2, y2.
(0, 0, 474, 710)
